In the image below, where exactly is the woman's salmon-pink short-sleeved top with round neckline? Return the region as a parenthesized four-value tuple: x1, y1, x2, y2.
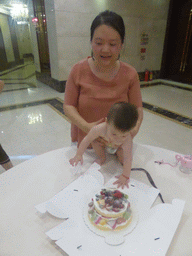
(64, 58, 142, 145)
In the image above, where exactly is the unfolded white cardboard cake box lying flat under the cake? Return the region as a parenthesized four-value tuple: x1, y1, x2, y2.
(36, 163, 185, 256)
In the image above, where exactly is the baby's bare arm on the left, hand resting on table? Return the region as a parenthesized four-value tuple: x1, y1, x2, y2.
(69, 125, 101, 166)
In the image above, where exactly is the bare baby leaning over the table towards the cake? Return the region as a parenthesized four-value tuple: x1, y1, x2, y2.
(69, 102, 138, 188)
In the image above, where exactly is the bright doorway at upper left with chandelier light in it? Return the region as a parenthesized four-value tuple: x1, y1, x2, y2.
(0, 0, 36, 84)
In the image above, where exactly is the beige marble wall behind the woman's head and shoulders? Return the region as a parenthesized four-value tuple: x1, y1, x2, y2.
(45, 0, 169, 80)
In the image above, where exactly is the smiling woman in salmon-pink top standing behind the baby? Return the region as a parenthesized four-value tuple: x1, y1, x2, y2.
(64, 11, 143, 186)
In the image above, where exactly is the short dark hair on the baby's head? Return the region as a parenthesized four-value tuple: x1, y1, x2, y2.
(107, 102, 138, 132)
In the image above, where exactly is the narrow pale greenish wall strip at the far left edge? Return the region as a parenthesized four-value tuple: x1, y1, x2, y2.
(0, 13, 15, 62)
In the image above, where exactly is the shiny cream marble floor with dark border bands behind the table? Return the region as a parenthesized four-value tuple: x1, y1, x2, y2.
(0, 61, 192, 173)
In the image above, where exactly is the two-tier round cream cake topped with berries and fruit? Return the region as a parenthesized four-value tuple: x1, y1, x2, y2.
(88, 188, 132, 231)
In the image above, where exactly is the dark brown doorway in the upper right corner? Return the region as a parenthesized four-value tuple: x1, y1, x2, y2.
(161, 0, 192, 84)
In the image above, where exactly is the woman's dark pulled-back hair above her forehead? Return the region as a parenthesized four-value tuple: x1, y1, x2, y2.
(91, 10, 125, 44)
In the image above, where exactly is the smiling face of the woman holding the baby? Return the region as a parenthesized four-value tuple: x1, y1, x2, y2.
(91, 25, 122, 66)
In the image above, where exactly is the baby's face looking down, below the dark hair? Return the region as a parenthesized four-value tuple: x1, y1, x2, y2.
(106, 123, 129, 144)
